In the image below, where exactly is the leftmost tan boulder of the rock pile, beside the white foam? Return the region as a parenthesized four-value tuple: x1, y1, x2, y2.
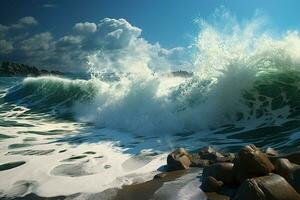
(167, 148, 191, 171)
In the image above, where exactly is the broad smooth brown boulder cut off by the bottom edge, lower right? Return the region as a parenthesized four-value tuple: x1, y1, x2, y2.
(235, 174, 300, 200)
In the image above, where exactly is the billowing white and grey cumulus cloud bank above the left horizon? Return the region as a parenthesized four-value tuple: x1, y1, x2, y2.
(0, 17, 189, 72)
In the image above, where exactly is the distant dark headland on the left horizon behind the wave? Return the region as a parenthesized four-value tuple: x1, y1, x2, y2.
(0, 62, 63, 77)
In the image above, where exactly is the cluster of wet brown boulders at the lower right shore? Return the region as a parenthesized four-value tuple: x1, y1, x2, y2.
(161, 145, 300, 200)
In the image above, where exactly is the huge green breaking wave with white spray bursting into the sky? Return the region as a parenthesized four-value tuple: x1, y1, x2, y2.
(4, 14, 300, 134)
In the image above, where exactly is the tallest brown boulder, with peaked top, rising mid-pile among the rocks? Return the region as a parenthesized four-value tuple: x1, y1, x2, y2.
(239, 145, 274, 178)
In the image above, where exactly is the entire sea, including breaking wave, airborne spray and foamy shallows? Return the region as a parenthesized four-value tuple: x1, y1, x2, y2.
(0, 15, 300, 198)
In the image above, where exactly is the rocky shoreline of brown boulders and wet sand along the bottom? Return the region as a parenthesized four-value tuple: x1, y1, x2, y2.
(0, 145, 300, 200)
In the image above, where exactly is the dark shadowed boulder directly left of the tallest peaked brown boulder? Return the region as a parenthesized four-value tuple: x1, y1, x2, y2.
(202, 162, 234, 184)
